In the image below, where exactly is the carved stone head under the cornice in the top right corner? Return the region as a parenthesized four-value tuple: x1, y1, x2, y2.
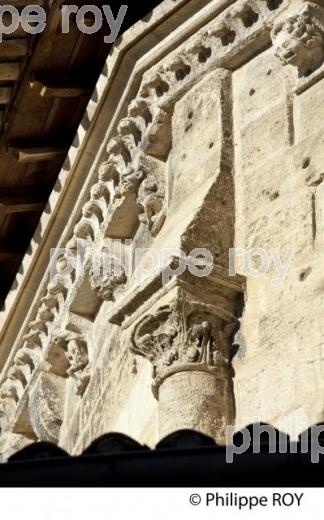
(271, 3, 324, 76)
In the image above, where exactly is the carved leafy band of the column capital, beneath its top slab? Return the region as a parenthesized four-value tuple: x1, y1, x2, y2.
(131, 294, 236, 398)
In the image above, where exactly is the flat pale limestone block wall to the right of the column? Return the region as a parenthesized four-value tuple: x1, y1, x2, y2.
(233, 43, 324, 434)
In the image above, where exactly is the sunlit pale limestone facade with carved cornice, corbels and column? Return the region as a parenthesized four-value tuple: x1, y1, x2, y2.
(0, 0, 324, 460)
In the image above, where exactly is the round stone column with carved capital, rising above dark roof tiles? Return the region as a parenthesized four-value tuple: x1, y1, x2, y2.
(123, 277, 239, 442)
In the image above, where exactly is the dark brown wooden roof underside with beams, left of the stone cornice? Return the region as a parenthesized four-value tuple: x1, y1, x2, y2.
(0, 0, 166, 303)
